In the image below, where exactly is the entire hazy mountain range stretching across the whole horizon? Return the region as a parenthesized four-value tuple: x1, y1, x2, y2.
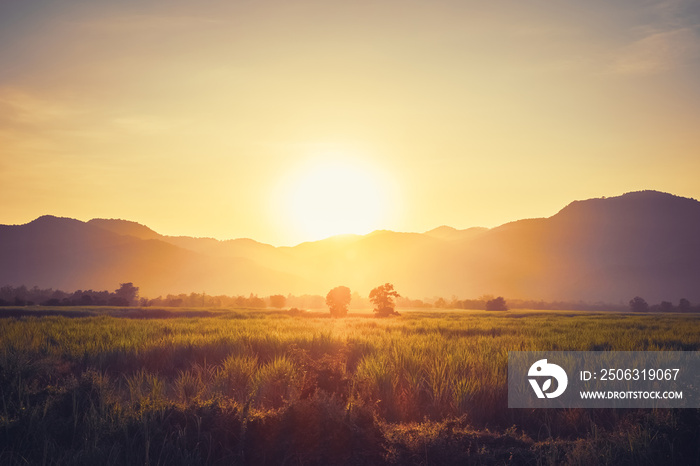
(0, 191, 700, 303)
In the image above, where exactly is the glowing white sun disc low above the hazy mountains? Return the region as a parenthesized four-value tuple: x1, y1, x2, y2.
(285, 155, 389, 241)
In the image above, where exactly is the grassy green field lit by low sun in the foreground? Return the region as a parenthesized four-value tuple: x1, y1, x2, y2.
(0, 308, 700, 466)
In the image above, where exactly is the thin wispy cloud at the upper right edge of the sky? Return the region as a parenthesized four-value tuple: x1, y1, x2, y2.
(610, 28, 700, 75)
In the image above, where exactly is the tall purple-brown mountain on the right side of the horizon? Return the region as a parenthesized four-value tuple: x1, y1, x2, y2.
(456, 191, 700, 302)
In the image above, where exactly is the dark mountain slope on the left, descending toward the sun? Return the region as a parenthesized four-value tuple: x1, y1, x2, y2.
(0, 216, 309, 297)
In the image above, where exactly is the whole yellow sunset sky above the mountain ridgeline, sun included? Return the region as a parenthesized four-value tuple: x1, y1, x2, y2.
(0, 0, 700, 245)
